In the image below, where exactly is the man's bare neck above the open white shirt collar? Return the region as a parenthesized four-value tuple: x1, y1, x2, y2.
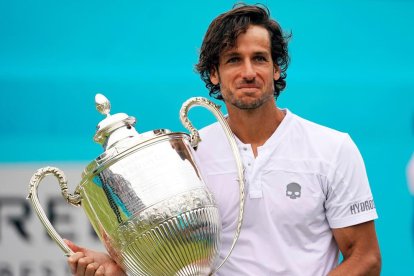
(227, 101, 285, 157)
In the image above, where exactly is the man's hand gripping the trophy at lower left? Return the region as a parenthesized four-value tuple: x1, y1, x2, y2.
(65, 240, 126, 276)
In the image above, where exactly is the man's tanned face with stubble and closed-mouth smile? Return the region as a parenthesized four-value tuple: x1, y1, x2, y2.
(210, 25, 280, 109)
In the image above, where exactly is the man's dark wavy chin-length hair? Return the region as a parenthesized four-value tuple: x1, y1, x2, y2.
(195, 4, 291, 100)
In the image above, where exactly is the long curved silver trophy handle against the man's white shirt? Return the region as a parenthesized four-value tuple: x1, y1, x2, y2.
(180, 97, 245, 274)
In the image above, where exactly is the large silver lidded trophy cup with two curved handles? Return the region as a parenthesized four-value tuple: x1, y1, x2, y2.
(28, 94, 244, 275)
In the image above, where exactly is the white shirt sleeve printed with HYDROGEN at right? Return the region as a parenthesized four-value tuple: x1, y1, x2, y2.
(325, 135, 378, 228)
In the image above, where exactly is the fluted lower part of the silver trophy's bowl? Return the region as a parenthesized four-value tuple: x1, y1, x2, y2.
(113, 206, 221, 276)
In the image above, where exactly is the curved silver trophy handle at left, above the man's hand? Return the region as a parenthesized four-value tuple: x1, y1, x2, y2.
(27, 167, 81, 257)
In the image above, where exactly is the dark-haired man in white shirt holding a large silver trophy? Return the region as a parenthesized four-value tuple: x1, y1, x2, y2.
(68, 5, 381, 276)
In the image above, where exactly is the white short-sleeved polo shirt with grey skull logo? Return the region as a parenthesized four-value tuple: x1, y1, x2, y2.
(196, 110, 377, 276)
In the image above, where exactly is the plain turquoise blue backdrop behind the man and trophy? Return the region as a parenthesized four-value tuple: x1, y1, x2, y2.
(0, 0, 414, 275)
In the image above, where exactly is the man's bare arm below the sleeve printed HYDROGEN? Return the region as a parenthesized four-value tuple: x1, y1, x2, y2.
(329, 221, 381, 276)
